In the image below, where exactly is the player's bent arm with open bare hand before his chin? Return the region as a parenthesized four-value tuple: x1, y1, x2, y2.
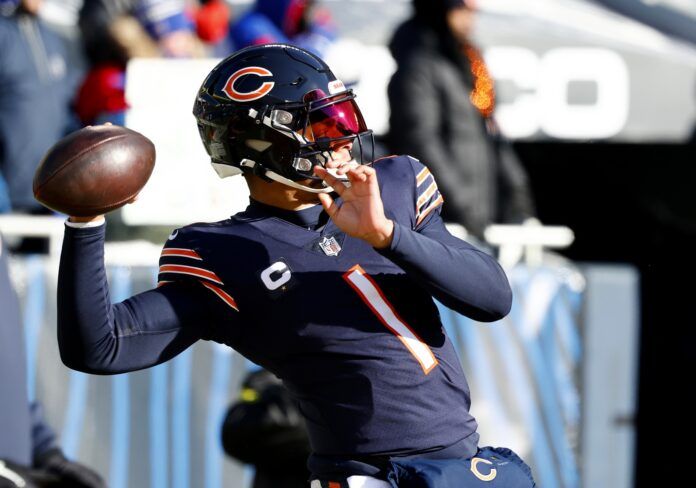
(316, 158, 512, 322)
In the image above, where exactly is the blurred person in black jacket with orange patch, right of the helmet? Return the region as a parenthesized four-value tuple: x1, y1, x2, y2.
(388, 0, 534, 237)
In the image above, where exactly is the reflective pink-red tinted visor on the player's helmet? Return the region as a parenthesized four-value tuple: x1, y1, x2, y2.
(304, 90, 367, 141)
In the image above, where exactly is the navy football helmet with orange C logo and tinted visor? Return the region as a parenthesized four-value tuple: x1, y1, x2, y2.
(193, 44, 374, 193)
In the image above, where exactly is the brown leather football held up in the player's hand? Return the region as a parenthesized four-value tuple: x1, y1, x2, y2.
(34, 125, 155, 217)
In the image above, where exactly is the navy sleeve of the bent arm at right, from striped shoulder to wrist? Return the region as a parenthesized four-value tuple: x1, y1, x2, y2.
(378, 157, 512, 322)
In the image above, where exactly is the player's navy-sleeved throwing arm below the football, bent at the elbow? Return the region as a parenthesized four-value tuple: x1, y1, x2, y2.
(58, 221, 218, 374)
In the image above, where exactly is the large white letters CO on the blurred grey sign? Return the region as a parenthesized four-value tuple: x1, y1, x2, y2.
(485, 46, 631, 139)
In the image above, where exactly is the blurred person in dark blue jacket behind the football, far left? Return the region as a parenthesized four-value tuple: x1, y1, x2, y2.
(0, 0, 74, 213)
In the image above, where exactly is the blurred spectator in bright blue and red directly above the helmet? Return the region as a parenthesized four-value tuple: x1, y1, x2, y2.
(230, 0, 336, 56)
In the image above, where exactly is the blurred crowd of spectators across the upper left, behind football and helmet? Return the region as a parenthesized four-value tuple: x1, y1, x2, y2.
(0, 0, 344, 214)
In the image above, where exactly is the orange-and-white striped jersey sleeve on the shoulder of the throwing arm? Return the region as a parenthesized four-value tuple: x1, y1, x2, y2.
(157, 229, 239, 312)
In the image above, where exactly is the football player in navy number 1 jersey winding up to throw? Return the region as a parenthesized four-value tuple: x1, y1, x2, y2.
(58, 44, 533, 488)
